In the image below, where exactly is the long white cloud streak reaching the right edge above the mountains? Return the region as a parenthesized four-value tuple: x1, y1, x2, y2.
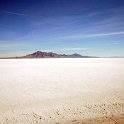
(62, 32, 124, 39)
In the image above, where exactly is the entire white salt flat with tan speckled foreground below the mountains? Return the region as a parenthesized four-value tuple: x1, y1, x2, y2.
(0, 58, 124, 124)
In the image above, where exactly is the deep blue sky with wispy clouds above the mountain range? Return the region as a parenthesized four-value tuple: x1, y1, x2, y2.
(0, 0, 124, 57)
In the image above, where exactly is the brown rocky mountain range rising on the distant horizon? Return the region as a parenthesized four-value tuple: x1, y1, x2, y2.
(23, 51, 95, 58)
